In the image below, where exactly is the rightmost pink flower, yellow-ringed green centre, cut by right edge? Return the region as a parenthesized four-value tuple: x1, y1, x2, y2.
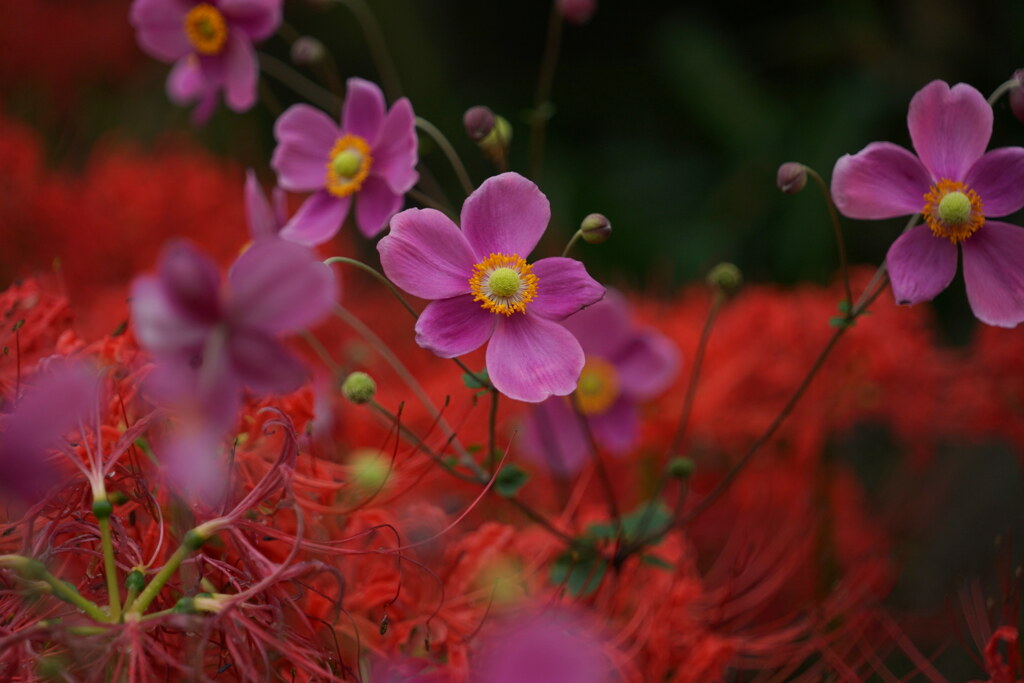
(833, 81, 1024, 328)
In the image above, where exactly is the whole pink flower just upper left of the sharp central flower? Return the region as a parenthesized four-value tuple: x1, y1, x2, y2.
(270, 78, 420, 245)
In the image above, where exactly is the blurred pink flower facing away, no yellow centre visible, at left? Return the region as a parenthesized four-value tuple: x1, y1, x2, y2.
(131, 240, 336, 428)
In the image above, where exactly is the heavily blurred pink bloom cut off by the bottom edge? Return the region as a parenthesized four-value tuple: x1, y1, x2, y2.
(472, 611, 612, 683)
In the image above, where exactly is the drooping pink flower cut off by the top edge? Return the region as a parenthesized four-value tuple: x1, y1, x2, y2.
(131, 0, 282, 122)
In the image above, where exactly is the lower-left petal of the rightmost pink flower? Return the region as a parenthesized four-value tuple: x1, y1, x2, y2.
(886, 225, 958, 304)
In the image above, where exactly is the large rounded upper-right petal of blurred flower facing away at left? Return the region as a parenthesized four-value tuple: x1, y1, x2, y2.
(227, 240, 337, 334)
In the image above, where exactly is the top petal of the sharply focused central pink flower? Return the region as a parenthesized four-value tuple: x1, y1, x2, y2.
(462, 173, 551, 261)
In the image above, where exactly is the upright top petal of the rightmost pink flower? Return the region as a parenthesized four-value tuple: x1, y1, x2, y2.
(906, 81, 992, 180)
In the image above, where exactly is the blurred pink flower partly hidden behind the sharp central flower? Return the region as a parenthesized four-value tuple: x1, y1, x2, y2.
(523, 292, 679, 474)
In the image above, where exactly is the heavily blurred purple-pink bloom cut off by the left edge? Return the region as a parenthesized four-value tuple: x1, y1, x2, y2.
(0, 359, 99, 503)
